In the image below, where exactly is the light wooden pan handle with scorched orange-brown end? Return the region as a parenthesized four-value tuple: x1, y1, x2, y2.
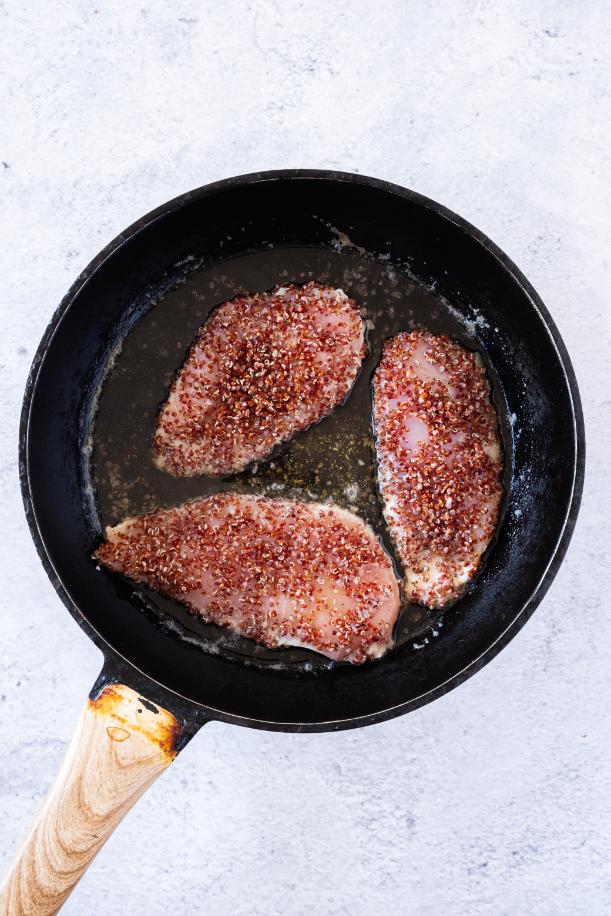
(0, 684, 180, 916)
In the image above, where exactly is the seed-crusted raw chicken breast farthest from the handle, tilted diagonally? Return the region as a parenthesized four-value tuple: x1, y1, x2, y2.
(153, 283, 366, 477)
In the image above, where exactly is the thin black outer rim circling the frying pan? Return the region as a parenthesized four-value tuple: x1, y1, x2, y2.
(19, 169, 585, 732)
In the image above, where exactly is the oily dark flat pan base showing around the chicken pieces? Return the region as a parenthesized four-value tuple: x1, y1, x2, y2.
(86, 240, 512, 671)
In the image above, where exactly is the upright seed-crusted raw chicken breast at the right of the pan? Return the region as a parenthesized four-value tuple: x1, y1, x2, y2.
(374, 331, 503, 608)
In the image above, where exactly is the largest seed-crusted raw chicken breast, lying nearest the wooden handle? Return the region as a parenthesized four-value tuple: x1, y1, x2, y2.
(94, 493, 400, 663)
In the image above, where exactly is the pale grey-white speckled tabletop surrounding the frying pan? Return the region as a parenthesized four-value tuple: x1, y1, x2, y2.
(0, 0, 611, 916)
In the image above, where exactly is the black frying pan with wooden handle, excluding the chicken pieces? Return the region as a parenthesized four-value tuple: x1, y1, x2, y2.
(0, 170, 584, 914)
